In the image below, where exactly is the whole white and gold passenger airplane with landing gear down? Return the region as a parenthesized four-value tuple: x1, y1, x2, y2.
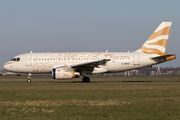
(3, 22, 176, 83)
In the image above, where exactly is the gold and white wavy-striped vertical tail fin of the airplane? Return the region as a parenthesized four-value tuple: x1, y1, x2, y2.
(137, 22, 172, 54)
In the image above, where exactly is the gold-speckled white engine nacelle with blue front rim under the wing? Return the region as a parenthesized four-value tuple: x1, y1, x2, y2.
(52, 67, 80, 79)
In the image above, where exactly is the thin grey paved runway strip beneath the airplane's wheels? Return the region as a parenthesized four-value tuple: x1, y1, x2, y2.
(0, 82, 180, 85)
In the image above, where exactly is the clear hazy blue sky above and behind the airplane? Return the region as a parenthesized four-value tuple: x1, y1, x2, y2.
(0, 0, 180, 69)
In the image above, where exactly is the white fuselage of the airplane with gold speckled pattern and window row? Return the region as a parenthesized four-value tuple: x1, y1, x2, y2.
(3, 52, 158, 73)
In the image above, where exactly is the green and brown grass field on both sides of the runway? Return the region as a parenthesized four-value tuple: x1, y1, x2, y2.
(0, 76, 180, 120)
